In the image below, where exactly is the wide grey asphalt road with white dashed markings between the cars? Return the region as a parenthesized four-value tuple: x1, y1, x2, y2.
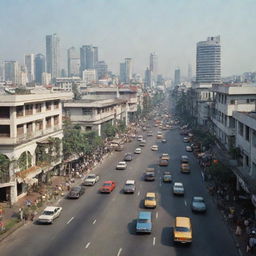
(0, 112, 238, 256)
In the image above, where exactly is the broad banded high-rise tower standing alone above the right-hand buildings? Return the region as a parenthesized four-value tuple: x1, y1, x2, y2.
(196, 36, 221, 83)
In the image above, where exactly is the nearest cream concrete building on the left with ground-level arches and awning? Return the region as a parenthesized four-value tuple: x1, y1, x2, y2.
(0, 93, 70, 203)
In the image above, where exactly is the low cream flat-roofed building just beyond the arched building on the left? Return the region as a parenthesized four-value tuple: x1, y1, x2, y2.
(64, 98, 128, 136)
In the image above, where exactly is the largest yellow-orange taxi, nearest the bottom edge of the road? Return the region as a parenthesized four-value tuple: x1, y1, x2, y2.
(173, 217, 192, 243)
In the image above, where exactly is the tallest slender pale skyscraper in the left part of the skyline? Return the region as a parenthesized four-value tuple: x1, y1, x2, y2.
(46, 34, 60, 78)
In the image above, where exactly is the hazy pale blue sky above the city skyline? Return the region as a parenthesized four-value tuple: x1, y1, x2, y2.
(0, 0, 256, 77)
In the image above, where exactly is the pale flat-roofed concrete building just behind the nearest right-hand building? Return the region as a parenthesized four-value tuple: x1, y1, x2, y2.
(211, 84, 256, 150)
